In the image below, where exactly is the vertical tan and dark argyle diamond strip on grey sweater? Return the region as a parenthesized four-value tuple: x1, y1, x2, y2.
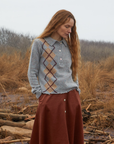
(40, 39, 57, 93)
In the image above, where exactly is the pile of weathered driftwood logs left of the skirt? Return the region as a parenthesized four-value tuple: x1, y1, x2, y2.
(0, 104, 38, 144)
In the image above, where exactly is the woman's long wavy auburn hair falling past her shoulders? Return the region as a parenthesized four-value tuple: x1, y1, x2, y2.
(33, 10, 81, 81)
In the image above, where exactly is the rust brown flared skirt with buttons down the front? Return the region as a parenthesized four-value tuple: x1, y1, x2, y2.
(30, 89, 84, 144)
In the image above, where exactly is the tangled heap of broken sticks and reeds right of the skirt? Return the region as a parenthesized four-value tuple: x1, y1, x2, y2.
(82, 99, 114, 144)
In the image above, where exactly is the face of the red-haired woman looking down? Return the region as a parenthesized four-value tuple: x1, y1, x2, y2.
(57, 18, 74, 38)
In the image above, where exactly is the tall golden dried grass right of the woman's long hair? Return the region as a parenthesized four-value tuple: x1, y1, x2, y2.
(79, 56, 114, 99)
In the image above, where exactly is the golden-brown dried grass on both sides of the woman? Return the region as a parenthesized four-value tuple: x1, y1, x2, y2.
(0, 50, 114, 120)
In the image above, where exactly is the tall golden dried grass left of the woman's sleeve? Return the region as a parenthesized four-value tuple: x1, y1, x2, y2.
(0, 50, 30, 91)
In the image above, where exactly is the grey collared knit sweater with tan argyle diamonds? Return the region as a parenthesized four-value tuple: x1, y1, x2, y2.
(28, 37, 80, 98)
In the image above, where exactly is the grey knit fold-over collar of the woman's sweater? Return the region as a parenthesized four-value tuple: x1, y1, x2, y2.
(44, 37, 67, 47)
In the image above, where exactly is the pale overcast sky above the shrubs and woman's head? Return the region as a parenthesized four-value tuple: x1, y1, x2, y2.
(0, 0, 114, 42)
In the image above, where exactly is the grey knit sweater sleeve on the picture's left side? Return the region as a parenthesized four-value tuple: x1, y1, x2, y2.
(28, 39, 42, 98)
